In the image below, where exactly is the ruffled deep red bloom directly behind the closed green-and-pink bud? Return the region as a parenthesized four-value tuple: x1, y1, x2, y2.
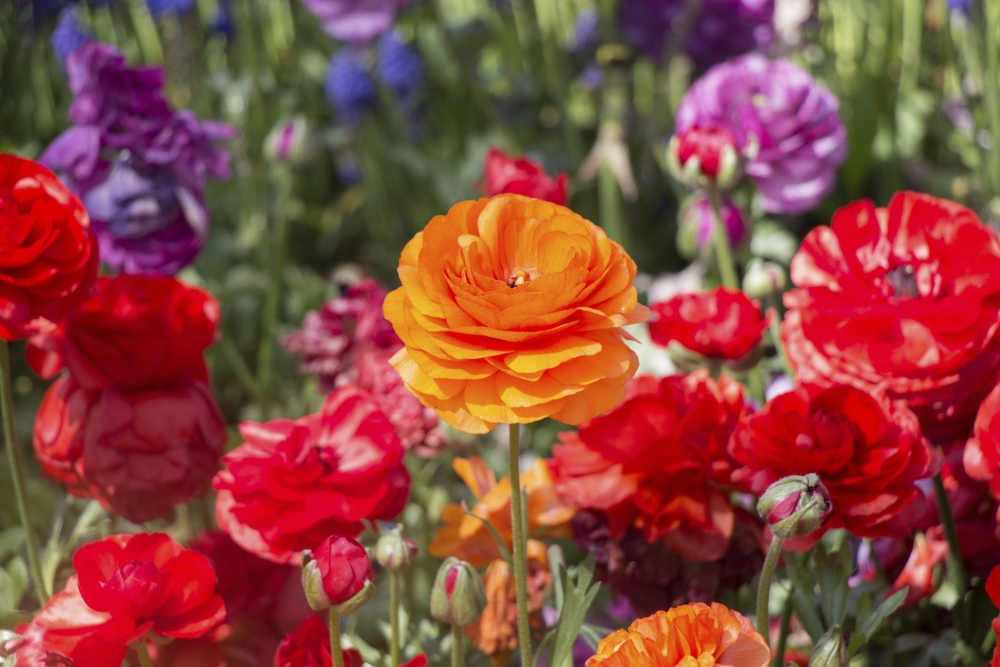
(729, 385, 939, 537)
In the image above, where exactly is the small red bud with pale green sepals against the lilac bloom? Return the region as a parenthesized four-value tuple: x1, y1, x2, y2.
(667, 126, 740, 188)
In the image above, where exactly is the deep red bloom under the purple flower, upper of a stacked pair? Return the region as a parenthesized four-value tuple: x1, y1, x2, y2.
(28, 274, 219, 390)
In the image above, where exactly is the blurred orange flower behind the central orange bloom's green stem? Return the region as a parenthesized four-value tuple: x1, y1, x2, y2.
(427, 456, 576, 567)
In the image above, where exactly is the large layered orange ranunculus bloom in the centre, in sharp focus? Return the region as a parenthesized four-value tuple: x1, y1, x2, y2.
(384, 194, 649, 433)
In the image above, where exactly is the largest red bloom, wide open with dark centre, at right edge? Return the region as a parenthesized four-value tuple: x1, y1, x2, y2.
(782, 192, 1000, 444)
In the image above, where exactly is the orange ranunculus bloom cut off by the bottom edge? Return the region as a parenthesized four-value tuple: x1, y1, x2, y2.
(587, 602, 771, 667)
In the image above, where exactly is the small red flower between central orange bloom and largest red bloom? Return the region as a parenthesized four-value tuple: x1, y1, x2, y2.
(649, 287, 770, 360)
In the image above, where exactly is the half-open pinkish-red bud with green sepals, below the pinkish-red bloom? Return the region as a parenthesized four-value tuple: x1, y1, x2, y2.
(302, 535, 375, 616)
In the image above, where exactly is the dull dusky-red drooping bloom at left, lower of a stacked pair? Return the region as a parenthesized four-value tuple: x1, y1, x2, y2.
(34, 376, 226, 523)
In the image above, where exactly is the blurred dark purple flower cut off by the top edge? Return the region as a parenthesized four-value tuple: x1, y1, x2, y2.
(619, 0, 774, 67)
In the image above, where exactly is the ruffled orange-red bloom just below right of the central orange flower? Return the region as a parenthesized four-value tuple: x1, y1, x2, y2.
(551, 371, 746, 561)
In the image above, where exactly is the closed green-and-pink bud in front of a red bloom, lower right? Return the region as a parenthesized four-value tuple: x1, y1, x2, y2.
(757, 473, 833, 539)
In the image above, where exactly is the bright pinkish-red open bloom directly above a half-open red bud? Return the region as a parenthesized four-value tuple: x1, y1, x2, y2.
(213, 386, 410, 563)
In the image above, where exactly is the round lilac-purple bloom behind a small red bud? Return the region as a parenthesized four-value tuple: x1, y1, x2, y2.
(675, 54, 847, 214)
